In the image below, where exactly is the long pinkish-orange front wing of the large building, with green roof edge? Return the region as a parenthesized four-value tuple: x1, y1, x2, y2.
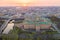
(24, 21, 51, 31)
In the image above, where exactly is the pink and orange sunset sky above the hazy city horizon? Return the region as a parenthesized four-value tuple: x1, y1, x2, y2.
(0, 0, 60, 6)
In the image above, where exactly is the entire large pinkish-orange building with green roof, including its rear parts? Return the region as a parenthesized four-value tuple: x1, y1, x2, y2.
(23, 15, 51, 31)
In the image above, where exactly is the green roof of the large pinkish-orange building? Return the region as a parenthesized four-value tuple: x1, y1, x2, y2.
(24, 18, 51, 26)
